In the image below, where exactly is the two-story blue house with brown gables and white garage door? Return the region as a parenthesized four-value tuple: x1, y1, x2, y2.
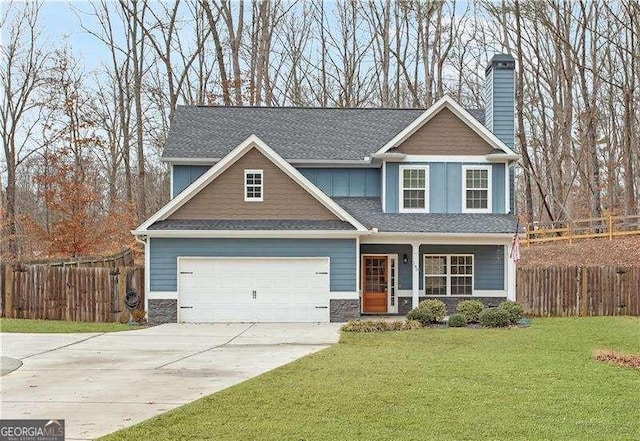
(133, 55, 519, 323)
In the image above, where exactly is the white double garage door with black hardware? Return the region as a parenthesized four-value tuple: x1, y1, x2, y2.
(178, 257, 329, 322)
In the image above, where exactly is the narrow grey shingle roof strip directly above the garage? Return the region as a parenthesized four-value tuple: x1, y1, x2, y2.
(149, 219, 355, 231)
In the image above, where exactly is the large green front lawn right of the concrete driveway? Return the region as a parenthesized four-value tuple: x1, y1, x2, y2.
(104, 317, 640, 440)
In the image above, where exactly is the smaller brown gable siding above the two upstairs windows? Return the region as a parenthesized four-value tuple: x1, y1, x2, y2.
(397, 107, 493, 155)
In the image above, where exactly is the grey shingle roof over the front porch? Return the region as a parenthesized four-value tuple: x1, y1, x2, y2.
(333, 198, 517, 233)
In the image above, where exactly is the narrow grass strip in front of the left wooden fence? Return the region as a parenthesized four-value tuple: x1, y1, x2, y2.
(0, 318, 139, 334)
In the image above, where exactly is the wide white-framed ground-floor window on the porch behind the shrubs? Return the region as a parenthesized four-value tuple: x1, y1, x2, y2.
(424, 254, 473, 296)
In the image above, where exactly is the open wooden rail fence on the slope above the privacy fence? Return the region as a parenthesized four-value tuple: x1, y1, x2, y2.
(522, 215, 640, 246)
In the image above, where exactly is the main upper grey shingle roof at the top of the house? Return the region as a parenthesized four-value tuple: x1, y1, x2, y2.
(162, 106, 484, 160)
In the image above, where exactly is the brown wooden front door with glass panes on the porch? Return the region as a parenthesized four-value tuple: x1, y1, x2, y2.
(362, 256, 389, 313)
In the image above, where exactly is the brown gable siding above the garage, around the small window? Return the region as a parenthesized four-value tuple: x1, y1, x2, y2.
(167, 148, 337, 220)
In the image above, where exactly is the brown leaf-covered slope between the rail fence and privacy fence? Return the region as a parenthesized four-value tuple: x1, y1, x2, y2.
(518, 235, 640, 267)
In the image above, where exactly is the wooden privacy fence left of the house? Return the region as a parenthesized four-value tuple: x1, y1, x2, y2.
(2, 264, 144, 322)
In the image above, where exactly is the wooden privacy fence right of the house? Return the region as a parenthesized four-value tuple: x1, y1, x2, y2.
(516, 266, 640, 316)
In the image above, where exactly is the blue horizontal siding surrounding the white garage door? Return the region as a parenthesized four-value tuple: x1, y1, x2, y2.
(149, 238, 356, 291)
